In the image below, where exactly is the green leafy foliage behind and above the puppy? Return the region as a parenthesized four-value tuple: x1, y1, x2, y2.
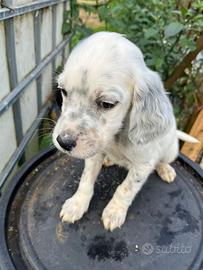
(63, 0, 203, 128)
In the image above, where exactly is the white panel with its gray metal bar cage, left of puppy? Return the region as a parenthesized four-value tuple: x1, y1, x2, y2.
(0, 0, 69, 187)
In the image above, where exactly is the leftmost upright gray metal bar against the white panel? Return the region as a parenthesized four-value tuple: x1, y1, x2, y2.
(5, 19, 23, 145)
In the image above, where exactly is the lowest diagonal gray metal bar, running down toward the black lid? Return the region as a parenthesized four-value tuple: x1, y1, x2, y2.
(0, 103, 50, 189)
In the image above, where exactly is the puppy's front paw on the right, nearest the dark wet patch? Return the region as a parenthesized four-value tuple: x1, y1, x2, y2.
(102, 199, 128, 231)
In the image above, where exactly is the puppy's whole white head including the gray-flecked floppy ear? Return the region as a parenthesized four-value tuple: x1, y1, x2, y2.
(53, 32, 172, 158)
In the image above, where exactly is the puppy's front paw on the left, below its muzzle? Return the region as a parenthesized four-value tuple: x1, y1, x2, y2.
(60, 195, 89, 223)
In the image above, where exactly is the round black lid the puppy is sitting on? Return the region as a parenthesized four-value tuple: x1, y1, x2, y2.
(7, 150, 203, 270)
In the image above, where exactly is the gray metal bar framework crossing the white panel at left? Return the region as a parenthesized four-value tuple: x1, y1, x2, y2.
(0, 0, 70, 189)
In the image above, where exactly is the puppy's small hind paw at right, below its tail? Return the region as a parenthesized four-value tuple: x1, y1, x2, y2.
(156, 163, 176, 183)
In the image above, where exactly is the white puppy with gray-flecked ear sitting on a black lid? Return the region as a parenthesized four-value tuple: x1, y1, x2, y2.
(53, 32, 198, 231)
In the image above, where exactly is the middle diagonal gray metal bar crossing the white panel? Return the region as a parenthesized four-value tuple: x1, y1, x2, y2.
(0, 36, 70, 115)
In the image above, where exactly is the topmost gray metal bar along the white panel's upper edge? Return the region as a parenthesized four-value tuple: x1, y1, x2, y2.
(0, 0, 67, 21)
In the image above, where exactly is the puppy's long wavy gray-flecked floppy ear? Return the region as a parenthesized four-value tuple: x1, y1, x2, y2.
(128, 70, 174, 144)
